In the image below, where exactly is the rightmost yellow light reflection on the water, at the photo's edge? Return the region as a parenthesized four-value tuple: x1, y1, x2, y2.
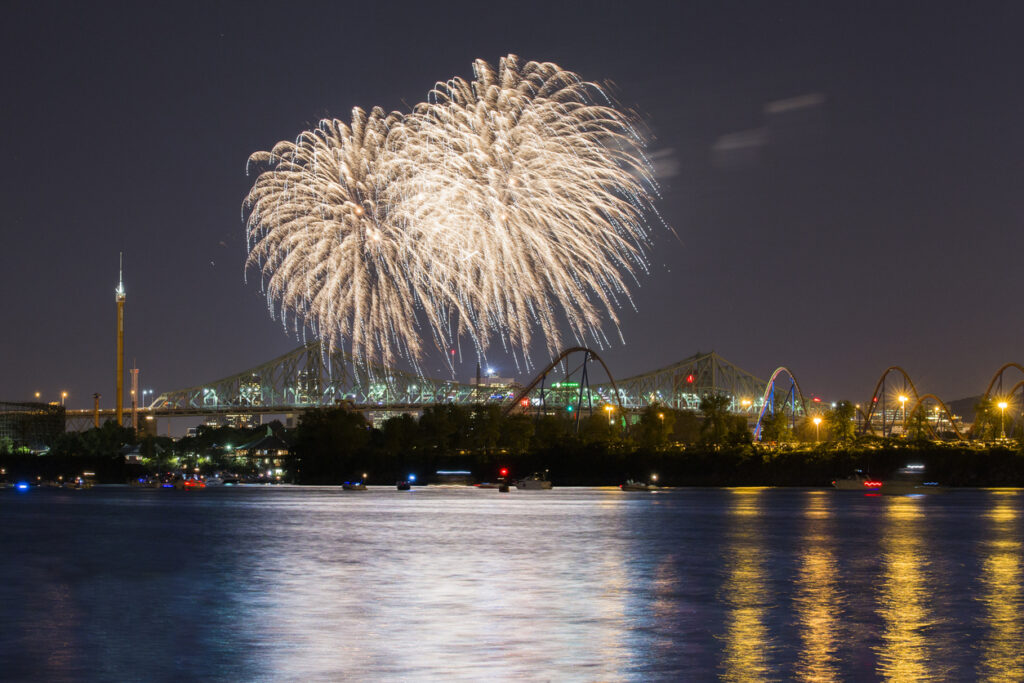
(979, 501, 1024, 681)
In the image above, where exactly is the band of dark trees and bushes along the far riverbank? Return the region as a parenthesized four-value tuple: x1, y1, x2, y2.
(6, 396, 1024, 486)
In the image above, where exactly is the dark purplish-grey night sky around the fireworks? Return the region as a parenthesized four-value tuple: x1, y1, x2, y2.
(0, 2, 1024, 408)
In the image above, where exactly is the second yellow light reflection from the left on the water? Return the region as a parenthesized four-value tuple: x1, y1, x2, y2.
(794, 492, 840, 681)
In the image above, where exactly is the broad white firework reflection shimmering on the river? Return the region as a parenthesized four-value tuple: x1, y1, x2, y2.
(252, 492, 635, 680)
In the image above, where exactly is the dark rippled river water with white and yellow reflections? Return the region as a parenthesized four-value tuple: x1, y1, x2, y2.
(0, 486, 1024, 681)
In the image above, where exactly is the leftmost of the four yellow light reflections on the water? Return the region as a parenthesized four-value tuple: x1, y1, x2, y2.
(722, 488, 772, 681)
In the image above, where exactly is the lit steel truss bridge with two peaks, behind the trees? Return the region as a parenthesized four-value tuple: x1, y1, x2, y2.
(86, 342, 765, 420)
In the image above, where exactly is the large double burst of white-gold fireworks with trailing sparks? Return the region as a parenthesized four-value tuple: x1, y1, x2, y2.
(245, 55, 655, 374)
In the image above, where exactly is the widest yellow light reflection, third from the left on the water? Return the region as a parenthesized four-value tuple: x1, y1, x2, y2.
(878, 497, 937, 681)
